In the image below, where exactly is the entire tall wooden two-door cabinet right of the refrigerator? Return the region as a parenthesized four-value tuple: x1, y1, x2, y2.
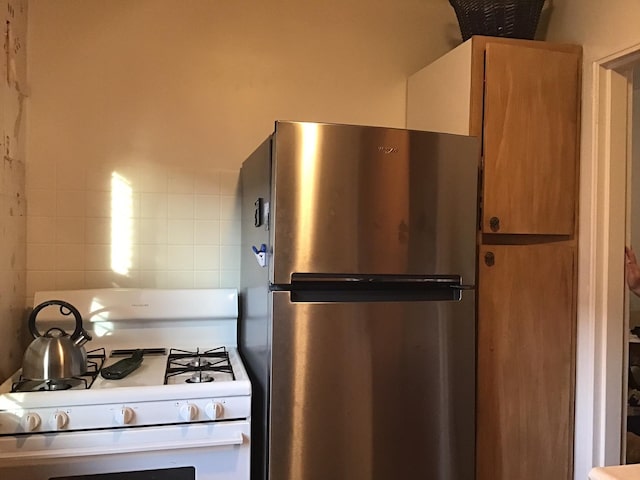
(407, 37, 582, 480)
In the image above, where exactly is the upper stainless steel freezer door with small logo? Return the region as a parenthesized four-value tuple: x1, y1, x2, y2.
(271, 122, 480, 284)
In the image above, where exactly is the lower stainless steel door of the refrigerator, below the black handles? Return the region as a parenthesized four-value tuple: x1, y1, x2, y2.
(268, 291, 475, 480)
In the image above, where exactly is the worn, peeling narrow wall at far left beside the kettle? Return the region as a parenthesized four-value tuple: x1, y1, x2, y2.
(0, 0, 27, 381)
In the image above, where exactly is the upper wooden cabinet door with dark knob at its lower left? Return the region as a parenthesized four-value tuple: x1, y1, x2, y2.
(482, 43, 580, 235)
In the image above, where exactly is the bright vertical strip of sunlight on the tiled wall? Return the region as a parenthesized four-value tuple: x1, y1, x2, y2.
(111, 172, 133, 275)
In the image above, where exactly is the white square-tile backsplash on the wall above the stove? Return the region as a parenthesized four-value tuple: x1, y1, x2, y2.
(26, 167, 240, 303)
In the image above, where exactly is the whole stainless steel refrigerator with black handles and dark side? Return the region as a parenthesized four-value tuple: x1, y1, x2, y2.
(238, 122, 480, 480)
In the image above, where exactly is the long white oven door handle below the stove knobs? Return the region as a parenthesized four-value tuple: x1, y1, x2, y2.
(0, 432, 245, 460)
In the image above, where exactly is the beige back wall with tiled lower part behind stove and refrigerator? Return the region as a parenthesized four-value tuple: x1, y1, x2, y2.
(26, 0, 460, 304)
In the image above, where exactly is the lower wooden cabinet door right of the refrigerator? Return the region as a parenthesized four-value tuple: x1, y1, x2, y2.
(476, 244, 575, 480)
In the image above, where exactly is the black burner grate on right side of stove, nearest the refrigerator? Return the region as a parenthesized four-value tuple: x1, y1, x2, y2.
(164, 347, 236, 385)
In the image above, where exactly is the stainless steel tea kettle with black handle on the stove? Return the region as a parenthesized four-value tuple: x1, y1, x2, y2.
(22, 300, 91, 380)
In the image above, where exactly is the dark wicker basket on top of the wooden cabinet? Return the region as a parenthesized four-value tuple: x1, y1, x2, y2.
(449, 0, 545, 40)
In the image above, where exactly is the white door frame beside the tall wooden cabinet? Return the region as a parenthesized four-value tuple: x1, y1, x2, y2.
(574, 45, 640, 480)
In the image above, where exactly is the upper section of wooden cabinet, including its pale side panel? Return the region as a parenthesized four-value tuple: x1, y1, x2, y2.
(407, 37, 581, 235)
